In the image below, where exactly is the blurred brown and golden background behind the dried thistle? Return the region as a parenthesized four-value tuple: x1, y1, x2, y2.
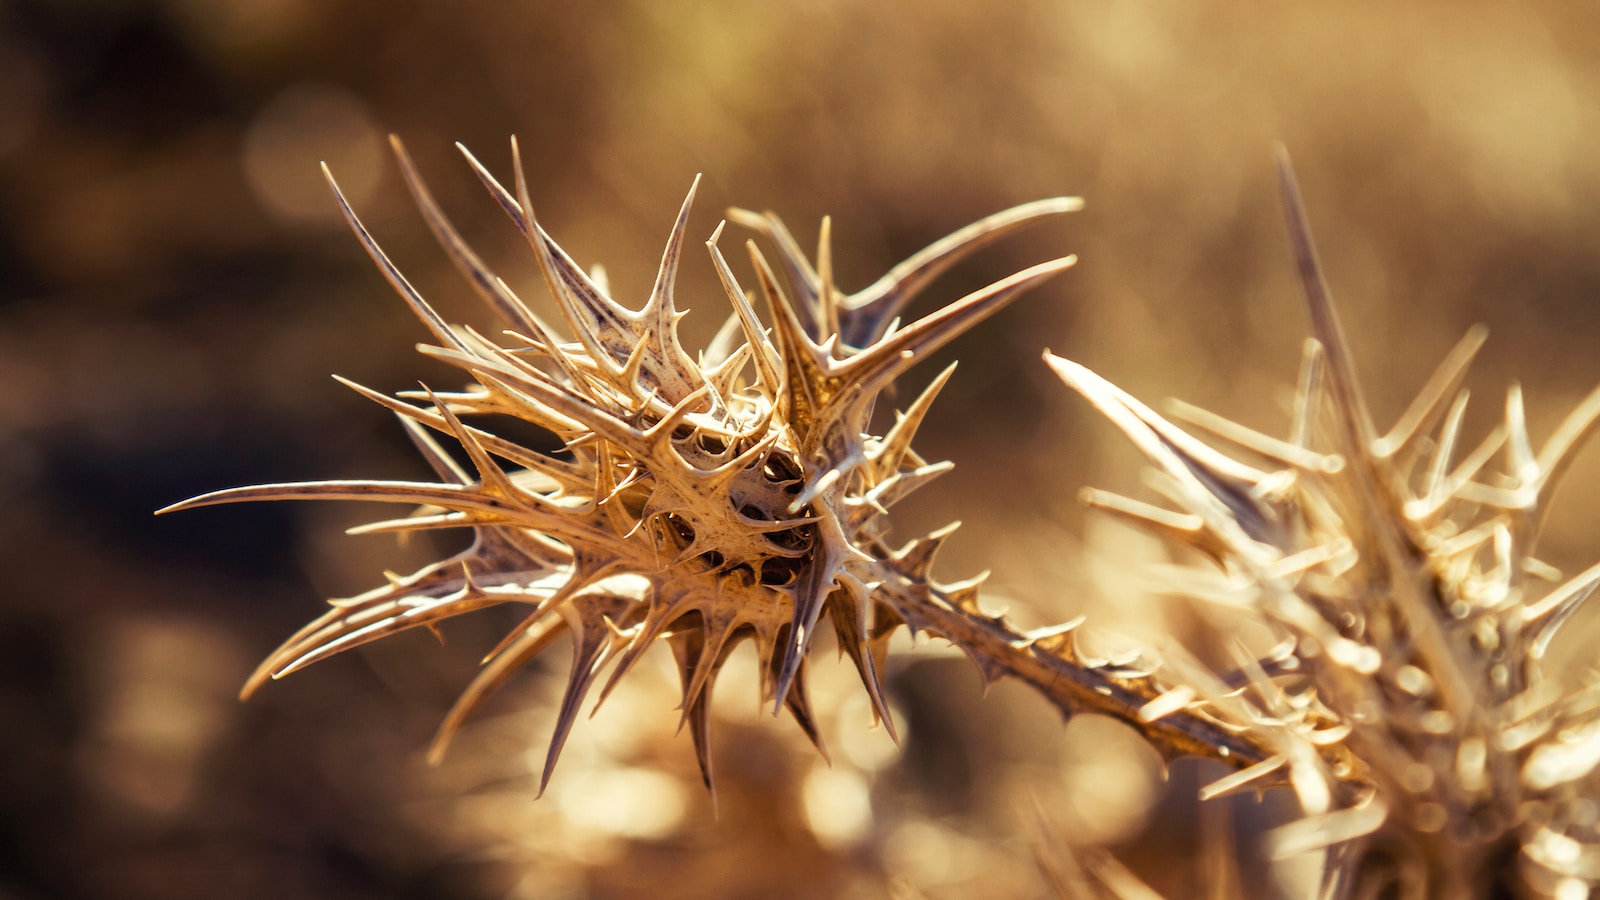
(9, 0, 1600, 898)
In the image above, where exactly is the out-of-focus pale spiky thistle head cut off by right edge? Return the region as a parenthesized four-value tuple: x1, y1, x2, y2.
(1046, 150, 1600, 898)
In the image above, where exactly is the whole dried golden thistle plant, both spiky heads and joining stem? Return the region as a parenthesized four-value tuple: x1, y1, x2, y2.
(170, 141, 1600, 898)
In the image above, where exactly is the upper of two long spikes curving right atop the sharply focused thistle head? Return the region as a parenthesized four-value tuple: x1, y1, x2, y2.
(840, 197, 1083, 348)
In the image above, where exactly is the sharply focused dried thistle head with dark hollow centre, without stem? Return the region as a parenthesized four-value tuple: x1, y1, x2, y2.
(170, 134, 1100, 785)
